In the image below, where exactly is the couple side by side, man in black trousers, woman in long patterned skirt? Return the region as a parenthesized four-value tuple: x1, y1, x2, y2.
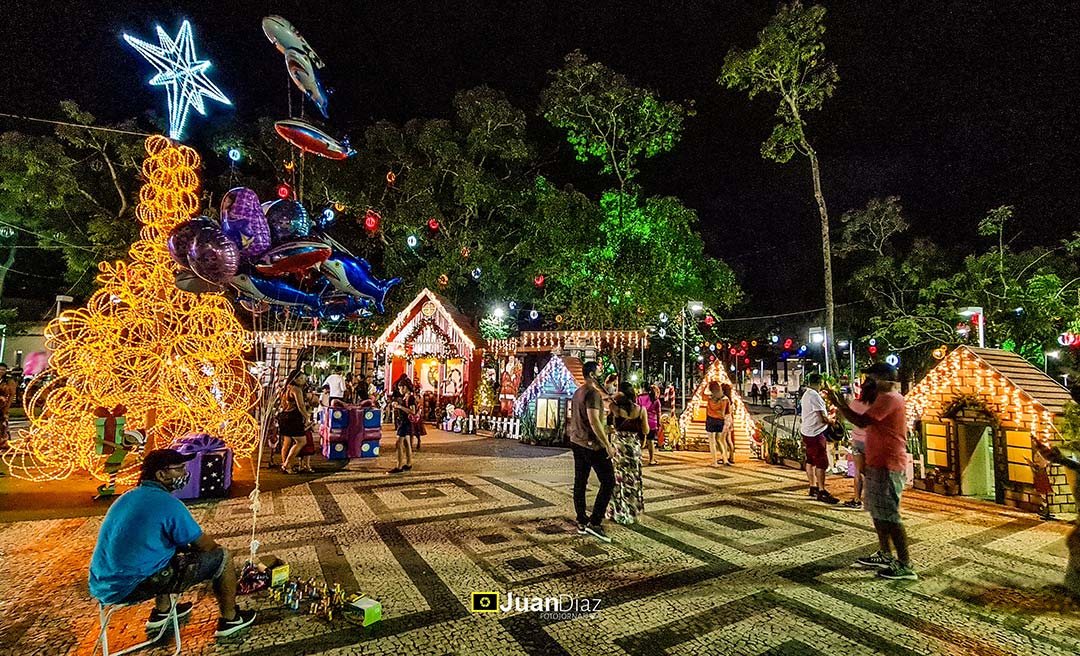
(568, 362, 649, 543)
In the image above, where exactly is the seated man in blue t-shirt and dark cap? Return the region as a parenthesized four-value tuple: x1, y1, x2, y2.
(90, 449, 255, 638)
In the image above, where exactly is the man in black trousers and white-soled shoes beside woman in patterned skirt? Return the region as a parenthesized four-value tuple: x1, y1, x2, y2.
(567, 362, 616, 543)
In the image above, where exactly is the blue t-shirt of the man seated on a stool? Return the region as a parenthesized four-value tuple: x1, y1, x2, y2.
(90, 483, 202, 603)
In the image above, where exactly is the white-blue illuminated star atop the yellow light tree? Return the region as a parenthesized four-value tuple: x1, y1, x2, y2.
(124, 21, 232, 140)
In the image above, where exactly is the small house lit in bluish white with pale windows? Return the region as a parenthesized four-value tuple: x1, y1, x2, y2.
(514, 354, 585, 442)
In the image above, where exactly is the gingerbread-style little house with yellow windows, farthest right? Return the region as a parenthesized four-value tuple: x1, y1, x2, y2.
(906, 346, 1076, 513)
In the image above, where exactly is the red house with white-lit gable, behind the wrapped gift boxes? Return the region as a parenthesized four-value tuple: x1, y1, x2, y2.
(374, 289, 484, 407)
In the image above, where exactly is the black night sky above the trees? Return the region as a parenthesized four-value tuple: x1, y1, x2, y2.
(0, 0, 1080, 313)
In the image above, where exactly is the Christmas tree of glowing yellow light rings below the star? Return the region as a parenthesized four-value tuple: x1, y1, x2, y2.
(4, 136, 259, 482)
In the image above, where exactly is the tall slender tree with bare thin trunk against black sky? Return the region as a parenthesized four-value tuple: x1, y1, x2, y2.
(718, 0, 839, 354)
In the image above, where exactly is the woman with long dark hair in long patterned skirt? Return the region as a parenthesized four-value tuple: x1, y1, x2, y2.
(607, 383, 649, 524)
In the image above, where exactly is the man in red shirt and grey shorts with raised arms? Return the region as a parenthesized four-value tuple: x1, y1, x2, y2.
(828, 363, 918, 580)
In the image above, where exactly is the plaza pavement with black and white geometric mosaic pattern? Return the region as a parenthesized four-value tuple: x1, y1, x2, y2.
(0, 431, 1080, 656)
